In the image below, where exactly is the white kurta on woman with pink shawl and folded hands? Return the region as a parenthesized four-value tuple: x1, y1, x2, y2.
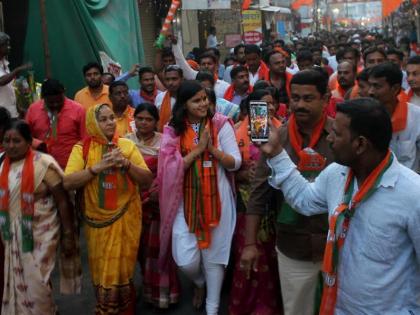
(172, 123, 241, 266)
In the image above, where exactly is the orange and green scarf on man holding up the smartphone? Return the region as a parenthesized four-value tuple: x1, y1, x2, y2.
(319, 151, 393, 315)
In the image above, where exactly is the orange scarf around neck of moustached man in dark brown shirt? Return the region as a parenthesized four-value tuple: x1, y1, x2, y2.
(277, 114, 327, 225)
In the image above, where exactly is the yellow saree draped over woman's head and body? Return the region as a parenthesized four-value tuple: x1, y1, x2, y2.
(65, 107, 148, 314)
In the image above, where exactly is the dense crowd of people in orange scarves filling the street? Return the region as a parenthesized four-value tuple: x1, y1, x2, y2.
(0, 25, 420, 315)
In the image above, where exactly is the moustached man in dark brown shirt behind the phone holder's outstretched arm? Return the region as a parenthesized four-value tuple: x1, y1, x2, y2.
(241, 69, 332, 315)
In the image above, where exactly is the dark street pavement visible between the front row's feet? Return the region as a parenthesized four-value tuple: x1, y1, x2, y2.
(52, 233, 228, 315)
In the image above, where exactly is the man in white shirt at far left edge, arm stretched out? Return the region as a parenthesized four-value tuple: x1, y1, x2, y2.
(0, 32, 32, 117)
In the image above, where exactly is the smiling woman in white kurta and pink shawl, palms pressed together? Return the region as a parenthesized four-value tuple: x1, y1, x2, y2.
(158, 81, 241, 315)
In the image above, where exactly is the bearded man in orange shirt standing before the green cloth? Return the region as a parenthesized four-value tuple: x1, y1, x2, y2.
(74, 62, 111, 110)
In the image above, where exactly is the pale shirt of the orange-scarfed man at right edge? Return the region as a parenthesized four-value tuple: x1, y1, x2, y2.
(390, 103, 420, 171)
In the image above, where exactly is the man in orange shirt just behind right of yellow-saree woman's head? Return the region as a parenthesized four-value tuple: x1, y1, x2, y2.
(109, 81, 135, 137)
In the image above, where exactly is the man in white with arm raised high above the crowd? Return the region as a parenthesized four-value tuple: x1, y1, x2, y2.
(171, 37, 229, 98)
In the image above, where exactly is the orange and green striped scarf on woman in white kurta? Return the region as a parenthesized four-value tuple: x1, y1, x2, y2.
(181, 120, 221, 249)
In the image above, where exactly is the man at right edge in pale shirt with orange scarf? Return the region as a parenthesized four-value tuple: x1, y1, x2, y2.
(368, 62, 420, 171)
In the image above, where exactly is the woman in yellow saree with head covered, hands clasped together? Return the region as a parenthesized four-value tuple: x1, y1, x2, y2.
(64, 104, 152, 314)
